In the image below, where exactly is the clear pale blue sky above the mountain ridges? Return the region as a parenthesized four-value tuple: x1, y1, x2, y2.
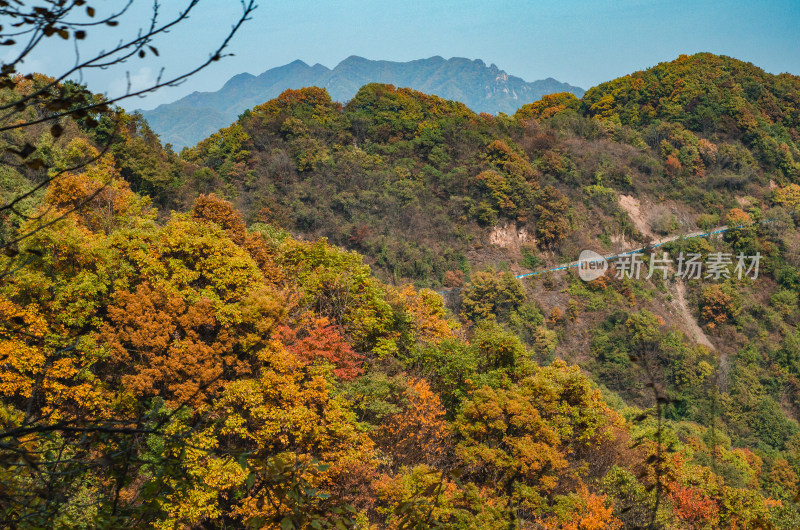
(10, 0, 800, 109)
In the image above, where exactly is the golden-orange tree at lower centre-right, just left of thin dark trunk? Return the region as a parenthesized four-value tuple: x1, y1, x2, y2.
(456, 361, 619, 514)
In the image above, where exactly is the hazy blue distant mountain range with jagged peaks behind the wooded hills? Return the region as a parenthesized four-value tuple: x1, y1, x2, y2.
(141, 56, 585, 149)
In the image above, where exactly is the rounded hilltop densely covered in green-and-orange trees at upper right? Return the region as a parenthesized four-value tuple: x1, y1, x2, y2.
(583, 53, 800, 178)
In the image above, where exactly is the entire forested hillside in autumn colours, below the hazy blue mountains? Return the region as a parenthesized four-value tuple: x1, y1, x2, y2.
(0, 54, 800, 529)
